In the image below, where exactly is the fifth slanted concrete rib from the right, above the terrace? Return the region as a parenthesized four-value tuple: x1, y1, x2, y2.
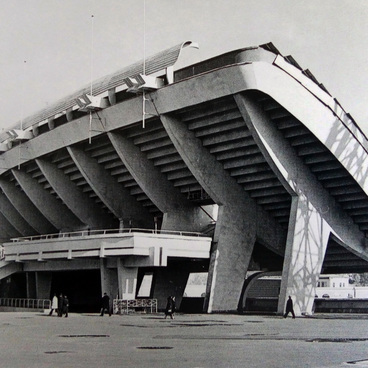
(36, 159, 109, 229)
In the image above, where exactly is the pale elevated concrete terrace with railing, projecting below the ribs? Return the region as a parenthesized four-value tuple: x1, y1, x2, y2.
(4, 229, 211, 267)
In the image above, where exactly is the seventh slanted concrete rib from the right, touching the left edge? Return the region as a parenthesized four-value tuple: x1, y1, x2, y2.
(0, 179, 56, 234)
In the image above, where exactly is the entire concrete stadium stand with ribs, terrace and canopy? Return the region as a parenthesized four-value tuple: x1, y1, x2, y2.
(0, 42, 368, 315)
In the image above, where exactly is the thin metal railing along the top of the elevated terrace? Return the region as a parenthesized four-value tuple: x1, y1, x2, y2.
(11, 228, 206, 243)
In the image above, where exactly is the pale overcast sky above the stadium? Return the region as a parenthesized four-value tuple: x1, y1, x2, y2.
(0, 0, 368, 132)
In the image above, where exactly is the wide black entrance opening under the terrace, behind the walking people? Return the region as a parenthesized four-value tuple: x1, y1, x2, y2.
(50, 270, 101, 313)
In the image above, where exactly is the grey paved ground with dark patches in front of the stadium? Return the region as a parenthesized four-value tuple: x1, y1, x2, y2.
(0, 312, 368, 368)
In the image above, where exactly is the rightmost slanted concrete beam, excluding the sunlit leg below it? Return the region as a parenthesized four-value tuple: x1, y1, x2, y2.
(235, 95, 368, 254)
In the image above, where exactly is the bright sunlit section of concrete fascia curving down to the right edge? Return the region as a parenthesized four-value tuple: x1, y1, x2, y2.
(239, 63, 368, 195)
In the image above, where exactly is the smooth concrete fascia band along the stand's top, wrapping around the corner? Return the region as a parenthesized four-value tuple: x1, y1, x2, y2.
(0, 51, 368, 185)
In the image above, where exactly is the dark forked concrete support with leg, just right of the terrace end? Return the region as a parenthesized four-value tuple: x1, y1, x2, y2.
(160, 115, 284, 313)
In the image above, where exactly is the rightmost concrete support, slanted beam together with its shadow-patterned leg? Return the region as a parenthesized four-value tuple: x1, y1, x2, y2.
(235, 94, 368, 314)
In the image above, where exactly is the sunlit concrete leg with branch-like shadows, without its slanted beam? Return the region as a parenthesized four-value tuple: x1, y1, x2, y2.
(277, 194, 331, 315)
